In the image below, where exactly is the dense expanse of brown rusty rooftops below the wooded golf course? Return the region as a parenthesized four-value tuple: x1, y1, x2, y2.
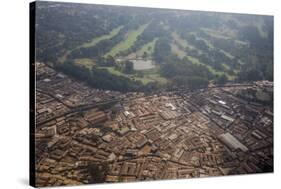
(35, 63, 273, 186)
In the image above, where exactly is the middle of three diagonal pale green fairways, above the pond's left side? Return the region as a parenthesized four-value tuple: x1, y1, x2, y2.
(105, 24, 148, 56)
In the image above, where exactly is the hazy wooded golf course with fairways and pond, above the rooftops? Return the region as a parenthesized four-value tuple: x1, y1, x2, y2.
(36, 2, 273, 91)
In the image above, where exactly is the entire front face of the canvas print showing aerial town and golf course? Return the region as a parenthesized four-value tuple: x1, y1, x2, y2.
(34, 1, 274, 187)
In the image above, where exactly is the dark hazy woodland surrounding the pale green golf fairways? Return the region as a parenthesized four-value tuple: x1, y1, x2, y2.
(36, 2, 273, 91)
